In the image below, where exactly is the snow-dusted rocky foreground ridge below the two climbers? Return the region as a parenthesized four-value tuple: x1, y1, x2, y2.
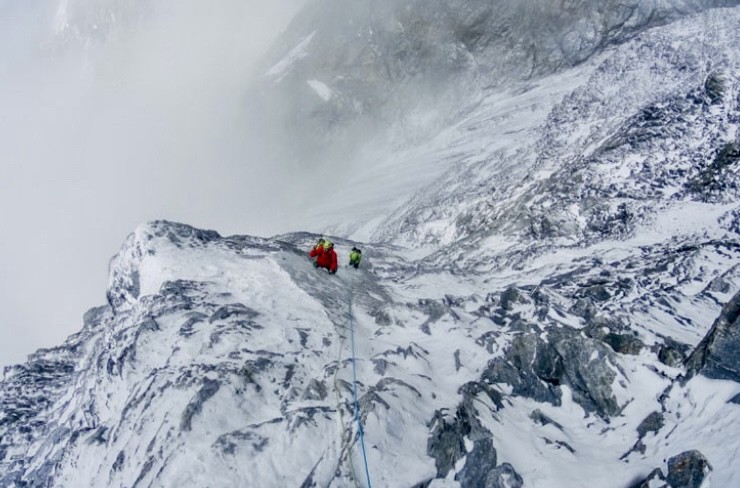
(0, 216, 740, 488)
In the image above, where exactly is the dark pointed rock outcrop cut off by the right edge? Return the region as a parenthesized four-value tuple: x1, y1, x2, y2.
(686, 292, 740, 382)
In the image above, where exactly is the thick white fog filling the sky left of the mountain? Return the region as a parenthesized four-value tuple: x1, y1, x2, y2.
(0, 0, 310, 366)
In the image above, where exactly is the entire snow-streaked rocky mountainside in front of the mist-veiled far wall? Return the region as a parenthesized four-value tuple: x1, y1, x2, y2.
(0, 2, 740, 488)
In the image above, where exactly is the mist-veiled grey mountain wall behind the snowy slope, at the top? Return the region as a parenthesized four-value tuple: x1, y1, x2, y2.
(255, 0, 738, 165)
